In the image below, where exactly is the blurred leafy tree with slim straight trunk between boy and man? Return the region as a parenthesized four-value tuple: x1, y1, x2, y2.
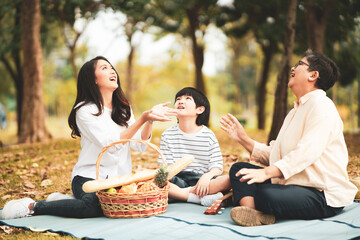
(216, 0, 286, 129)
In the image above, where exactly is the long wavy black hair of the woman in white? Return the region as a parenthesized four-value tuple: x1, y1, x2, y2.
(68, 56, 131, 138)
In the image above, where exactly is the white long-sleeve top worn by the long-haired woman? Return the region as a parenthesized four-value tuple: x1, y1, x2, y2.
(72, 103, 147, 179)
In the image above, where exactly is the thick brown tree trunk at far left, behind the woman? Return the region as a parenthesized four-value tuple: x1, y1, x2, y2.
(19, 0, 50, 143)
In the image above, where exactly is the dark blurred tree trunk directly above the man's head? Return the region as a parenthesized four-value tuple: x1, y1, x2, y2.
(304, 0, 335, 52)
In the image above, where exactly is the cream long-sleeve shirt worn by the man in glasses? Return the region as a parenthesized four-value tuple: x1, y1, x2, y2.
(251, 90, 357, 207)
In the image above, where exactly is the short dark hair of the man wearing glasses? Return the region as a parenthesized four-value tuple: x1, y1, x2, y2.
(304, 49, 340, 91)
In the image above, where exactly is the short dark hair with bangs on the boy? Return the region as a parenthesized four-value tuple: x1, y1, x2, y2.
(175, 87, 210, 126)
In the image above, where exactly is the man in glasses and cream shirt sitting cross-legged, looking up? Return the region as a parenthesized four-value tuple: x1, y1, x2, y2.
(221, 50, 357, 226)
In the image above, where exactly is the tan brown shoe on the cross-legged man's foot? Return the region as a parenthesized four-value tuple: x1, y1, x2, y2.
(230, 206, 275, 227)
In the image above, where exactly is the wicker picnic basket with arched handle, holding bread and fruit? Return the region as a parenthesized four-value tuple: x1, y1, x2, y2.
(96, 139, 169, 218)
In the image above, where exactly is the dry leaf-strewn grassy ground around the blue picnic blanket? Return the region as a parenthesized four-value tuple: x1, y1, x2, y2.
(0, 130, 360, 239)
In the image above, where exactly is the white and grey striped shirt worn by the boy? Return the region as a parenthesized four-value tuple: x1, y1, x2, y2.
(159, 125, 223, 174)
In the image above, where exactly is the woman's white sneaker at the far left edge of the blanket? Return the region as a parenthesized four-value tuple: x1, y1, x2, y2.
(2, 198, 35, 220)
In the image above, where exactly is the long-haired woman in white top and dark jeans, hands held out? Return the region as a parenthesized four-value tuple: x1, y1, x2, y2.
(2, 57, 176, 219)
